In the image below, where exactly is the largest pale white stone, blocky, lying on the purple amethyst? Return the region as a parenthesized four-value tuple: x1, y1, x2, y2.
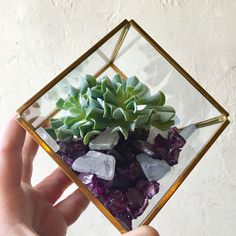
(72, 151, 116, 180)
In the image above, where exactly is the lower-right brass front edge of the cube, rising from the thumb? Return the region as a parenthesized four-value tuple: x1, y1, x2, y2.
(140, 119, 230, 225)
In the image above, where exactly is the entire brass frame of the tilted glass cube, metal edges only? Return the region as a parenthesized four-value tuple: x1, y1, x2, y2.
(17, 20, 229, 233)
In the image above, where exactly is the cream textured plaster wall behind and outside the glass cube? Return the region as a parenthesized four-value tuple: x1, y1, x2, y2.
(0, 0, 236, 236)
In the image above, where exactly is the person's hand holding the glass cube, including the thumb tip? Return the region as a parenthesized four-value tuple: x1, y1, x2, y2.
(0, 119, 158, 236)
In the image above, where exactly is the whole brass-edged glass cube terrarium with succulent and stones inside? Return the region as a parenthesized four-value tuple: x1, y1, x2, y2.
(18, 20, 229, 233)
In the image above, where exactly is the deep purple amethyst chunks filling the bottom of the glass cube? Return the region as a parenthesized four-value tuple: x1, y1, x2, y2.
(58, 128, 186, 230)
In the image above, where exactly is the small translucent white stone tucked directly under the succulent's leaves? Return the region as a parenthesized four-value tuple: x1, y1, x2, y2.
(89, 128, 119, 150)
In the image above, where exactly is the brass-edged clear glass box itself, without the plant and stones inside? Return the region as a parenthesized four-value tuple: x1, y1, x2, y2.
(17, 20, 229, 233)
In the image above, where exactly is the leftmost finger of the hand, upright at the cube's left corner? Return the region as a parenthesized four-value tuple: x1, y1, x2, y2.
(0, 116, 25, 188)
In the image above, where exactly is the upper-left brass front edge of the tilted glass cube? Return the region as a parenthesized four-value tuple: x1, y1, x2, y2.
(17, 19, 129, 114)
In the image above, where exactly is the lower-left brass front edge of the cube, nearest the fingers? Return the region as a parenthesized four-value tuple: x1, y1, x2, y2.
(17, 115, 127, 233)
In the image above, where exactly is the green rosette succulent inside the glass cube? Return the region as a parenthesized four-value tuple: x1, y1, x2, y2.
(51, 75, 175, 144)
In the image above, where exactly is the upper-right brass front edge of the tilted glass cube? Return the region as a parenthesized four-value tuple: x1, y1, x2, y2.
(130, 20, 229, 117)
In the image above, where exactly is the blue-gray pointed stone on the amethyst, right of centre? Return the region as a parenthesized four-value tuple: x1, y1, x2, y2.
(136, 153, 170, 181)
